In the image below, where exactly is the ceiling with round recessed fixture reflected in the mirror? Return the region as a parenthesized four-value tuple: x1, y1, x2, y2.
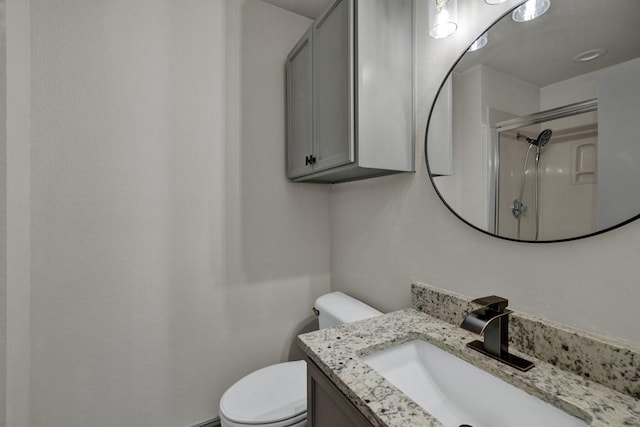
(456, 0, 640, 87)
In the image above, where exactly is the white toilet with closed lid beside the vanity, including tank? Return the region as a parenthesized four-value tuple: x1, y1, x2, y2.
(220, 292, 382, 427)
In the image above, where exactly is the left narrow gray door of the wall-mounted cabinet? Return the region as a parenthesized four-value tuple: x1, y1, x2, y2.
(287, 29, 313, 178)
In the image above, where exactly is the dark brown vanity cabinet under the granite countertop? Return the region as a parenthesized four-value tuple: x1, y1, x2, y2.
(307, 358, 372, 427)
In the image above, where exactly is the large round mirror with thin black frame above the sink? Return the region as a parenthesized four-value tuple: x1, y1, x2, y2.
(426, 0, 640, 242)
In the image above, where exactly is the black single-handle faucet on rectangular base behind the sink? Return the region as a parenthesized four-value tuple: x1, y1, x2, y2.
(460, 295, 534, 371)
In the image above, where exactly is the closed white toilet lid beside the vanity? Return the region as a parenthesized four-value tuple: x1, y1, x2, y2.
(220, 360, 307, 424)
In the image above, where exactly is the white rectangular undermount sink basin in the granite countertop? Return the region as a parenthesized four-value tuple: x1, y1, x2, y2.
(364, 340, 587, 427)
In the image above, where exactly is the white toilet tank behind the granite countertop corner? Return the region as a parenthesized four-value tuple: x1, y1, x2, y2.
(316, 292, 382, 329)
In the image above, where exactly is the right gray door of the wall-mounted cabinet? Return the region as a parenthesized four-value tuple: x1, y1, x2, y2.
(313, 0, 355, 171)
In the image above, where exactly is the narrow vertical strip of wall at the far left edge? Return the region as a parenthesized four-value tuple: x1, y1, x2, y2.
(2, 0, 31, 427)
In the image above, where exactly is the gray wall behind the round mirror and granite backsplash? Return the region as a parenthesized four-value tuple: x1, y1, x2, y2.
(331, 0, 640, 343)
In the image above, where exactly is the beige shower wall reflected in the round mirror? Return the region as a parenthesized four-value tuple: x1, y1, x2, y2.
(498, 112, 597, 240)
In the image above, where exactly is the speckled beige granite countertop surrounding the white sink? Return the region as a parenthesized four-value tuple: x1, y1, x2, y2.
(298, 309, 640, 427)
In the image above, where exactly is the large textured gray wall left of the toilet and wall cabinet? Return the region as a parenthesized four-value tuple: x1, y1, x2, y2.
(28, 0, 330, 427)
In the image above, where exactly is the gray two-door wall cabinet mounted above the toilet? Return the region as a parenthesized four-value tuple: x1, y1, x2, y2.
(286, 0, 414, 183)
